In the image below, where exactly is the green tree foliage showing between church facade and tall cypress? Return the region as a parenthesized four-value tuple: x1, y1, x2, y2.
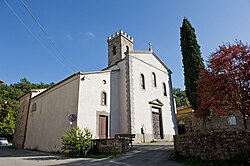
(173, 88, 190, 107)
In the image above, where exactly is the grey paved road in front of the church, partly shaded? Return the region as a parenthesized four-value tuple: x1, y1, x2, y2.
(0, 143, 184, 166)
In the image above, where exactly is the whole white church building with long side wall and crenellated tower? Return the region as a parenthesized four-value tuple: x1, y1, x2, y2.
(13, 31, 177, 152)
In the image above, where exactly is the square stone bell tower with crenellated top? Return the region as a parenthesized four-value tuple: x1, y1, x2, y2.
(108, 30, 133, 66)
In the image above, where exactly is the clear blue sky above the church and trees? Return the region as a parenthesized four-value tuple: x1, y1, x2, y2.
(0, 0, 250, 89)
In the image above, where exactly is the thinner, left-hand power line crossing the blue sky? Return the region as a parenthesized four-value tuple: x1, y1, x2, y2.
(3, 0, 72, 71)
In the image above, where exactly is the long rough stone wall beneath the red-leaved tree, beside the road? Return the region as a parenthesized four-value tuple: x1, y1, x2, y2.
(174, 131, 250, 161)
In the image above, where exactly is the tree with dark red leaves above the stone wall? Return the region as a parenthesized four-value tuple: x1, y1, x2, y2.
(196, 41, 250, 129)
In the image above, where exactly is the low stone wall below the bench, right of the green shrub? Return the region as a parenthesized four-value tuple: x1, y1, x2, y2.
(93, 138, 127, 152)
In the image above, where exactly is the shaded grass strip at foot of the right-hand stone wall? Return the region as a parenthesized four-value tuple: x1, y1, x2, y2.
(170, 152, 249, 166)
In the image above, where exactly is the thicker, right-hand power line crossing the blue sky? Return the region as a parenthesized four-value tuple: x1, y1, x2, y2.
(20, 0, 76, 72)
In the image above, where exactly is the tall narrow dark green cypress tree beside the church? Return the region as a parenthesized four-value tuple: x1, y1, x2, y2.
(180, 18, 205, 110)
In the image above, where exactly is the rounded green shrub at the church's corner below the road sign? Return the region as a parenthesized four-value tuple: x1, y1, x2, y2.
(61, 127, 95, 157)
